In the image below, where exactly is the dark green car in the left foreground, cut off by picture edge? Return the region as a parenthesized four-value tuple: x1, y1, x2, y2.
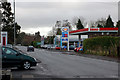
(2, 47, 37, 69)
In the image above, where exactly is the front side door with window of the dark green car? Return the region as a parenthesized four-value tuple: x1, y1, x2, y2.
(2, 47, 20, 66)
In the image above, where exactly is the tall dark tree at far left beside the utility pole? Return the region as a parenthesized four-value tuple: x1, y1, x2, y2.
(2, 2, 21, 44)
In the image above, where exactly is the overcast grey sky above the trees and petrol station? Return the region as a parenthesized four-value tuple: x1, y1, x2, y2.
(9, 0, 118, 35)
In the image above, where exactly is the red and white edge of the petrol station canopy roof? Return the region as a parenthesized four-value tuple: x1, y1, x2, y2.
(69, 28, 118, 35)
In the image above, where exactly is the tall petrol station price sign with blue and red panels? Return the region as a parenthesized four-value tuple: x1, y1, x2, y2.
(61, 27, 69, 51)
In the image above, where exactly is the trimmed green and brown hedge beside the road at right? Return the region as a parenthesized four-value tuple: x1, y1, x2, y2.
(83, 36, 120, 56)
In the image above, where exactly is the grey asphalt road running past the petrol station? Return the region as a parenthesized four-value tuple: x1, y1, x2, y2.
(12, 46, 118, 78)
